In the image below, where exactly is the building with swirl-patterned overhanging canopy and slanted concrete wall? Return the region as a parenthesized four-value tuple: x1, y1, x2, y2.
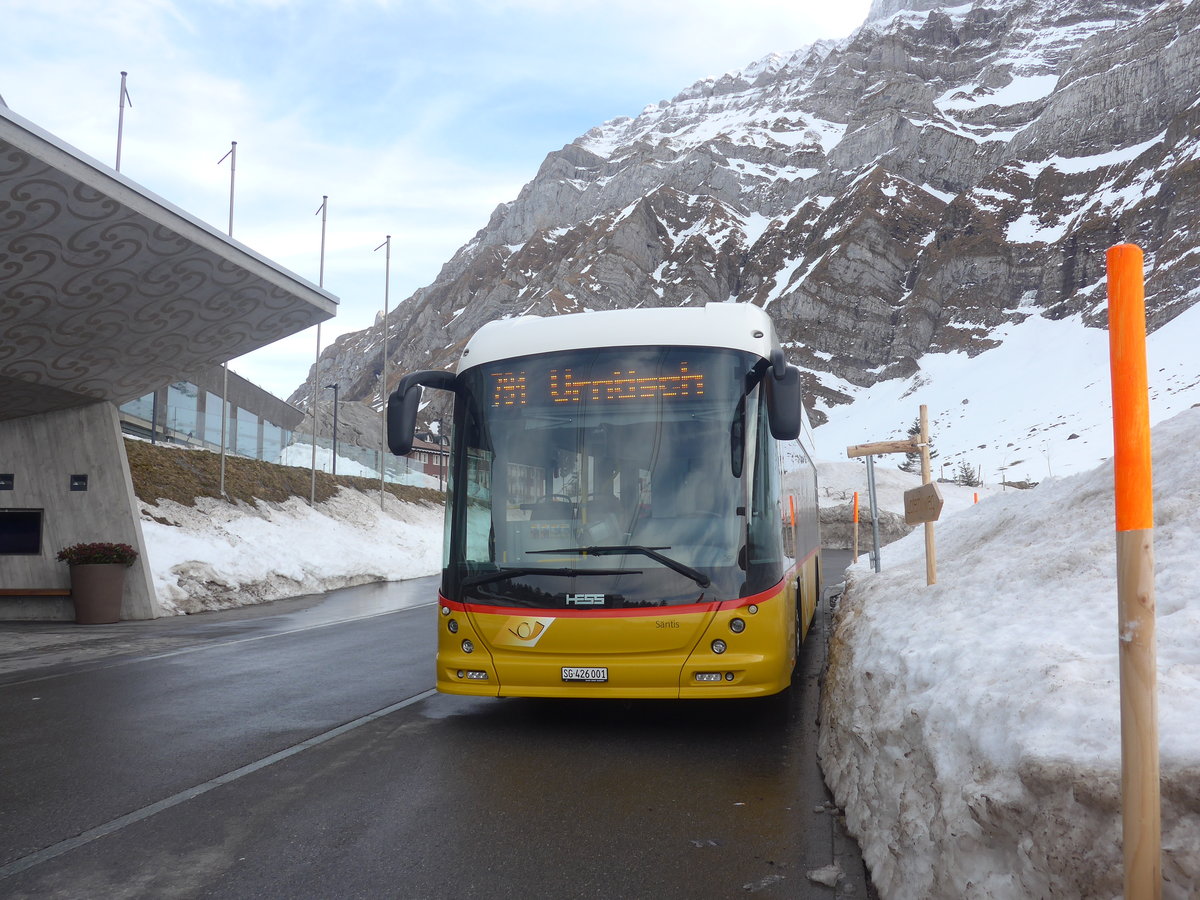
(0, 102, 337, 619)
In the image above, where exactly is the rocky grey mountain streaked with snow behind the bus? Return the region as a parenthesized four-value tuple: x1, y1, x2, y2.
(292, 0, 1200, 480)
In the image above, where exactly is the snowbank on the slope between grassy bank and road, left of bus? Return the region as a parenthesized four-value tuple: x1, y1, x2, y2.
(142, 487, 442, 614)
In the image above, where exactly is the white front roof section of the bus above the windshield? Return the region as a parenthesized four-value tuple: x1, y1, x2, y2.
(457, 304, 779, 372)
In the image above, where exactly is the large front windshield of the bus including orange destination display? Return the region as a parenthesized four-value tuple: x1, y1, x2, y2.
(443, 347, 763, 610)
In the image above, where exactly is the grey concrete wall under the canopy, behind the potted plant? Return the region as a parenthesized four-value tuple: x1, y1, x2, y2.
(0, 402, 161, 620)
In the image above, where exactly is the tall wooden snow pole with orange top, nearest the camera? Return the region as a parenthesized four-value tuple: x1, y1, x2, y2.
(1108, 244, 1163, 900)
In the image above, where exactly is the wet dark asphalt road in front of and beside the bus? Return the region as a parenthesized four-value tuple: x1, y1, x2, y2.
(0, 560, 869, 898)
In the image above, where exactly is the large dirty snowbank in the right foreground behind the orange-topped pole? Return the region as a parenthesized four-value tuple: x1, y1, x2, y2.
(820, 409, 1200, 898)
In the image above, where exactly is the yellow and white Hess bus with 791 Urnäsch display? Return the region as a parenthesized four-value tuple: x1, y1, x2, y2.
(388, 304, 820, 698)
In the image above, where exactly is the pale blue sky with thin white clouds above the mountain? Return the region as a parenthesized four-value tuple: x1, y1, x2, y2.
(0, 0, 870, 397)
